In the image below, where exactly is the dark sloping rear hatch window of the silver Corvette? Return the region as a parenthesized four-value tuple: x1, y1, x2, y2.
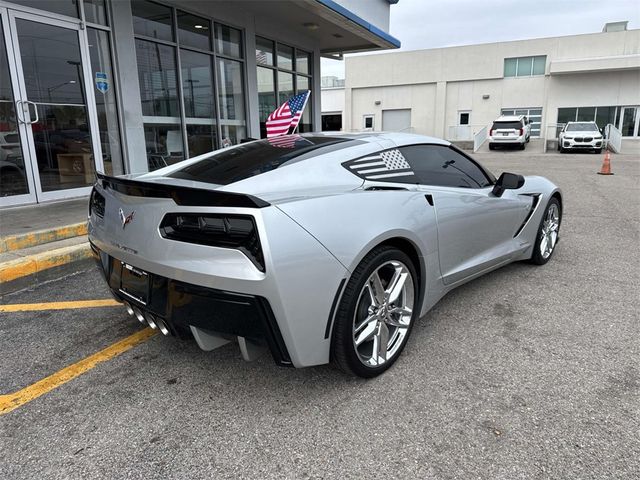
(169, 135, 362, 185)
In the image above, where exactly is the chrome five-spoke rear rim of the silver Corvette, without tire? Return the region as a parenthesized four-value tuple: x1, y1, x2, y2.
(353, 260, 414, 367)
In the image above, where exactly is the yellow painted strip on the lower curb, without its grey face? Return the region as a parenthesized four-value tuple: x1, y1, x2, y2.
(0, 243, 92, 283)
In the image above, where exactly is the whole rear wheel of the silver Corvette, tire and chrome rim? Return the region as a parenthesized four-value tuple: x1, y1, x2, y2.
(331, 246, 419, 378)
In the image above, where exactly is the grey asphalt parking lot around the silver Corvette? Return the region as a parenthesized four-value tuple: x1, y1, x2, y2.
(0, 151, 640, 479)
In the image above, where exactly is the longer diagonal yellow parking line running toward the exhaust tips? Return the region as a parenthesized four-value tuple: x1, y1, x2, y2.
(0, 327, 158, 415)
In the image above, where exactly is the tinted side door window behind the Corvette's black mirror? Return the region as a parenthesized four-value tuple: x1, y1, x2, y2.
(400, 145, 491, 188)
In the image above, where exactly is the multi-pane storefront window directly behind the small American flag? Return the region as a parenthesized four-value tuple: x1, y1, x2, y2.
(256, 37, 313, 138)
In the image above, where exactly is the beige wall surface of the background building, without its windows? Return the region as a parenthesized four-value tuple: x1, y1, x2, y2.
(344, 30, 640, 137)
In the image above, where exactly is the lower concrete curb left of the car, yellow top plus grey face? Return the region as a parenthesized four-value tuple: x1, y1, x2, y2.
(0, 243, 93, 294)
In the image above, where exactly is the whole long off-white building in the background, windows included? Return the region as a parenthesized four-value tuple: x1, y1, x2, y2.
(322, 22, 640, 152)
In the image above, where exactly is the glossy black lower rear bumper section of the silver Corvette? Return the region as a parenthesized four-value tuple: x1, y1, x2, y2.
(91, 243, 292, 366)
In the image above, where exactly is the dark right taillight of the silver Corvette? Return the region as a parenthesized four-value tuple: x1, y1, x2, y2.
(160, 213, 265, 272)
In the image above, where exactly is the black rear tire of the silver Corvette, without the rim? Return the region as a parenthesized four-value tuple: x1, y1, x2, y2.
(331, 245, 420, 378)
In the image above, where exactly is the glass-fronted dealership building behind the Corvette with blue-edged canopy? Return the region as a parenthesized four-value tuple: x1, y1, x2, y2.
(0, 0, 400, 208)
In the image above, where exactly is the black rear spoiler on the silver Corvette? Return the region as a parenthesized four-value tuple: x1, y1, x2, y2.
(97, 173, 270, 208)
